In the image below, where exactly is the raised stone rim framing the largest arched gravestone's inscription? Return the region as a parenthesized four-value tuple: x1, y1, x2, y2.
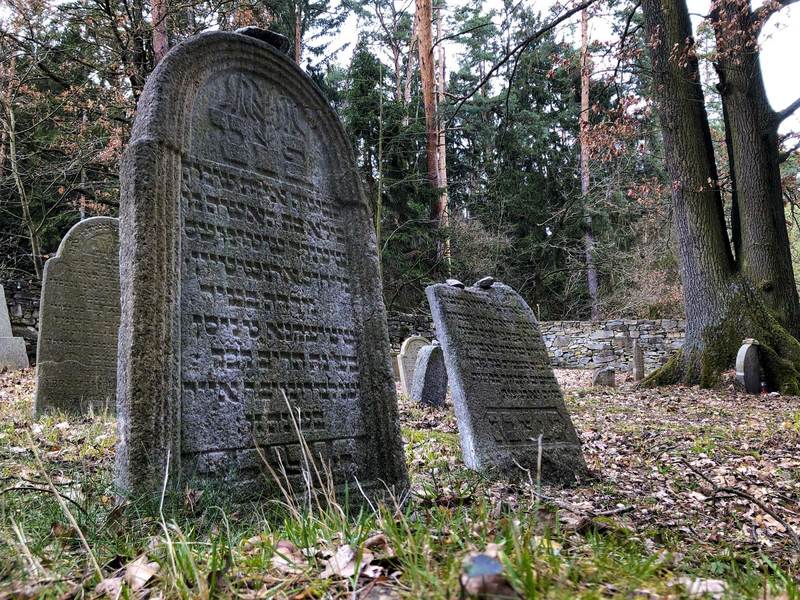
(116, 31, 408, 498)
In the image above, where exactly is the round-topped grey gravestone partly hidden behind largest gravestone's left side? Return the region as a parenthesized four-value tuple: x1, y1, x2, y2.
(36, 217, 119, 413)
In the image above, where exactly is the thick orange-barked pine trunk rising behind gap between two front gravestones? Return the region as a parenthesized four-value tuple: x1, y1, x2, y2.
(416, 0, 441, 206)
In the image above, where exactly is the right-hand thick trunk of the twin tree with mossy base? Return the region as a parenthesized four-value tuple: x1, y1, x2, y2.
(712, 0, 800, 337)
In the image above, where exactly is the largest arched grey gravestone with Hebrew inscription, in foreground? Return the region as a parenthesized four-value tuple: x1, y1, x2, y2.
(117, 32, 407, 497)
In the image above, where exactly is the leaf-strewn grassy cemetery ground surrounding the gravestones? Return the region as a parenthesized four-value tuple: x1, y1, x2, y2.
(0, 370, 800, 600)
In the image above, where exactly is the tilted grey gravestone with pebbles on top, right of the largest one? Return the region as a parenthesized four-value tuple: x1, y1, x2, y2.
(425, 278, 586, 483)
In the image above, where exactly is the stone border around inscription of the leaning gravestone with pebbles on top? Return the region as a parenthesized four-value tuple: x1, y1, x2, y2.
(425, 283, 589, 485)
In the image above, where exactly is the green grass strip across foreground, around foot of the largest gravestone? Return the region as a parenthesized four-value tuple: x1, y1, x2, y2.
(0, 382, 800, 599)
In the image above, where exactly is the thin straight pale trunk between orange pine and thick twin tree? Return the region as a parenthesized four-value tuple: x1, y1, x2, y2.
(580, 8, 600, 321)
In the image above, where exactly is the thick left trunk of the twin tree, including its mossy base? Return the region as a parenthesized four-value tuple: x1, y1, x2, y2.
(642, 0, 800, 393)
